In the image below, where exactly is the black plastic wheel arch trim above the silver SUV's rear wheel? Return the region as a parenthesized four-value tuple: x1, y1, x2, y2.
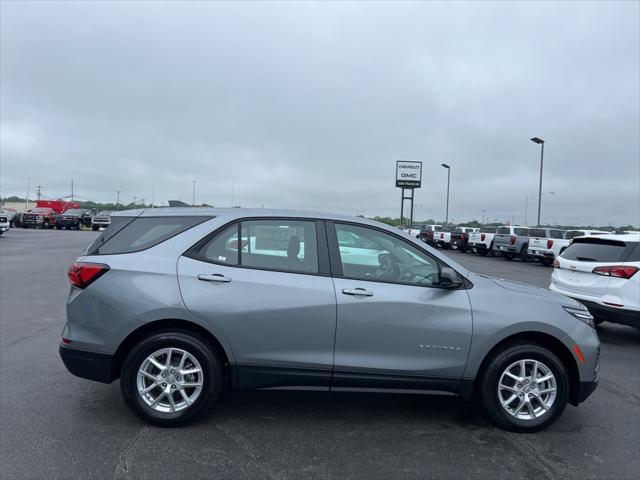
(111, 319, 235, 382)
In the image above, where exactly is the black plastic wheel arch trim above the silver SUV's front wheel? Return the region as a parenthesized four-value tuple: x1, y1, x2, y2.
(461, 331, 580, 405)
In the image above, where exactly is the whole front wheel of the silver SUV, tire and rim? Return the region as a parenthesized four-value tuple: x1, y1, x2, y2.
(479, 343, 569, 432)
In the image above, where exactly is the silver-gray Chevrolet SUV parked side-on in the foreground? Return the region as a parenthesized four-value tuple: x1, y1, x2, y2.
(60, 208, 599, 431)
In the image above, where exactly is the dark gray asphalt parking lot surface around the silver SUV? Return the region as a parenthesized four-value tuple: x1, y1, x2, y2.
(0, 229, 640, 480)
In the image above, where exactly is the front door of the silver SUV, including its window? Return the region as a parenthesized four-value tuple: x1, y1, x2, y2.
(327, 222, 472, 391)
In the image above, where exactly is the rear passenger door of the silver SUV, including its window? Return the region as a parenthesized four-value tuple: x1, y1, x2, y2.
(178, 218, 336, 388)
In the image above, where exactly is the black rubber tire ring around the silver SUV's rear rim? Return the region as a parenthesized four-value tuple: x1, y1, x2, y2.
(120, 329, 223, 427)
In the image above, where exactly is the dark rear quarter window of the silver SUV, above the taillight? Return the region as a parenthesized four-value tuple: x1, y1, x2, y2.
(87, 216, 212, 255)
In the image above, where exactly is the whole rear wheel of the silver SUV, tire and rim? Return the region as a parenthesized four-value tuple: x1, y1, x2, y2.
(120, 329, 223, 427)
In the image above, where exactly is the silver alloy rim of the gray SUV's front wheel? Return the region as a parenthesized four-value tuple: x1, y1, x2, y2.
(498, 359, 558, 420)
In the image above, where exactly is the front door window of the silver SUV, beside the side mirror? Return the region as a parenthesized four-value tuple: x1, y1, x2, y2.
(336, 224, 440, 286)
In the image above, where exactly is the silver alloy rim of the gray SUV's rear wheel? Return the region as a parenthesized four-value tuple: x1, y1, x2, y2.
(136, 348, 204, 413)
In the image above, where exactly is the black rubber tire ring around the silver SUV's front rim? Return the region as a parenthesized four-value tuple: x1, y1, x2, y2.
(479, 343, 569, 432)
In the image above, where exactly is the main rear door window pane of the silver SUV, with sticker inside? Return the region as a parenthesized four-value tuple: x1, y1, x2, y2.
(240, 220, 318, 273)
